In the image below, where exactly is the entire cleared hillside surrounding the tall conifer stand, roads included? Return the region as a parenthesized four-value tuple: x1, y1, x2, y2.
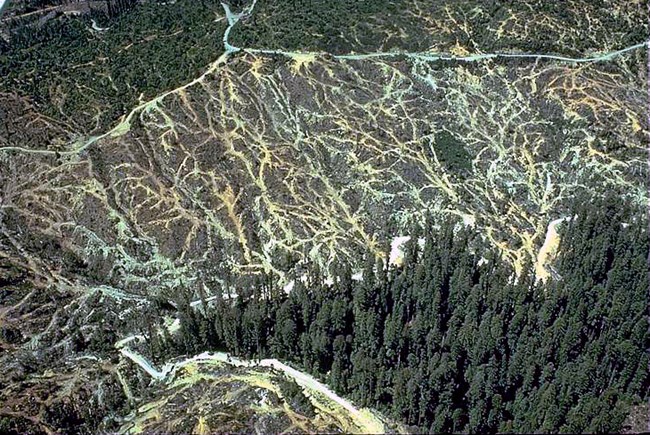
(0, 0, 650, 433)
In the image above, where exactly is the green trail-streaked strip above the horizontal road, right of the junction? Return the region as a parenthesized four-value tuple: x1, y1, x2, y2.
(232, 0, 647, 55)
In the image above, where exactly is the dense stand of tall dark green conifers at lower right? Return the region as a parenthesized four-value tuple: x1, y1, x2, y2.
(151, 198, 650, 433)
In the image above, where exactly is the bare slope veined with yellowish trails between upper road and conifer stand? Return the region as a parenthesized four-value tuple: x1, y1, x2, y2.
(3, 46, 647, 295)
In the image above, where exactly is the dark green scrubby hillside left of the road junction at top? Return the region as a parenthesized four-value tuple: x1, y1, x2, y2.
(0, 0, 227, 132)
